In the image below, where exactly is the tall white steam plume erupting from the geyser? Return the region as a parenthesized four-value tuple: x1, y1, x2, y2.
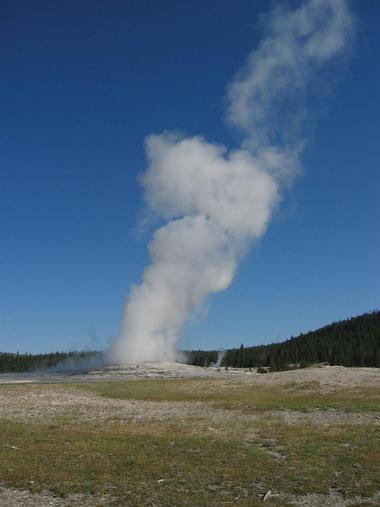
(109, 0, 353, 362)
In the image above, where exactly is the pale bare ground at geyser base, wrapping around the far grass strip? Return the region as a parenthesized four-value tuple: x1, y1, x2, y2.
(0, 363, 380, 424)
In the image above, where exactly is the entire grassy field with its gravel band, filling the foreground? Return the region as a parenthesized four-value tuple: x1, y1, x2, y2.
(0, 372, 380, 506)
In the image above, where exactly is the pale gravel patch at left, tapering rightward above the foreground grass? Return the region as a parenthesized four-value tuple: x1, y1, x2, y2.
(0, 385, 243, 432)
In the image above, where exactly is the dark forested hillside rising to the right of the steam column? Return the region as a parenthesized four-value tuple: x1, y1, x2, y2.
(186, 311, 380, 371)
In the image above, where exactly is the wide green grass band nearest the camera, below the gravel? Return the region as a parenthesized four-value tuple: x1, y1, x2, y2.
(0, 420, 380, 506)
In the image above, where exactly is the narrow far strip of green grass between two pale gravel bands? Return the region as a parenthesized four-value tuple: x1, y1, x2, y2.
(76, 379, 380, 412)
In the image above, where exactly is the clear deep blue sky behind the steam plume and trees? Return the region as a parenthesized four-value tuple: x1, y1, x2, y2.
(0, 0, 380, 352)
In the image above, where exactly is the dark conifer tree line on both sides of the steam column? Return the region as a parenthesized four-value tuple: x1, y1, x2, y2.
(0, 311, 380, 373)
